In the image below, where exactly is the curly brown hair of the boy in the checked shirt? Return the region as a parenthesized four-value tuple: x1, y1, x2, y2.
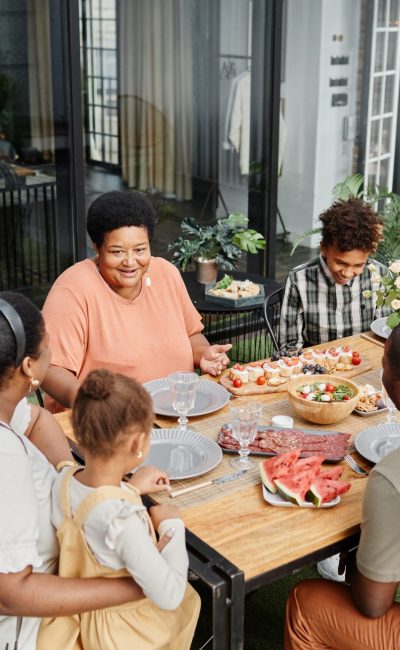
(319, 198, 383, 253)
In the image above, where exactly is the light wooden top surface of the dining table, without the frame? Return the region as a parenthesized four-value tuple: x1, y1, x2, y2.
(57, 335, 384, 581)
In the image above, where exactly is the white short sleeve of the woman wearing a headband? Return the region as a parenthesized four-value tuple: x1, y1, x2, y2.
(0, 427, 42, 573)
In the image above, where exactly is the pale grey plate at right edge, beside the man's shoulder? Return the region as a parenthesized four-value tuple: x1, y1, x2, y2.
(354, 422, 400, 463)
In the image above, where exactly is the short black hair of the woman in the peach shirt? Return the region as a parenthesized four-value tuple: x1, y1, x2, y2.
(86, 191, 156, 247)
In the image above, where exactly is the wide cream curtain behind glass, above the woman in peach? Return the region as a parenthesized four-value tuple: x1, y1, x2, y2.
(118, 0, 193, 199)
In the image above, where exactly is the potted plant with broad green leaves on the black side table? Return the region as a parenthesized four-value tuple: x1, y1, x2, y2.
(168, 212, 266, 284)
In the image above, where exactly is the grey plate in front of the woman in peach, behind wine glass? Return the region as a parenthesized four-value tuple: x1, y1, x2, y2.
(143, 378, 231, 418)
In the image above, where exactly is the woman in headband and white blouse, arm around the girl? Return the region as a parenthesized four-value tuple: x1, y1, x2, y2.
(0, 292, 166, 650)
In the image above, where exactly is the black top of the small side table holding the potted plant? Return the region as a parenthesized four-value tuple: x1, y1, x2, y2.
(182, 271, 282, 313)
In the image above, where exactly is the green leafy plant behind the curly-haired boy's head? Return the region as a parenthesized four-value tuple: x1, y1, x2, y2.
(291, 174, 400, 266)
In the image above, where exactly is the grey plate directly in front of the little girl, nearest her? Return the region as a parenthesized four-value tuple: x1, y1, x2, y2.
(143, 429, 222, 479)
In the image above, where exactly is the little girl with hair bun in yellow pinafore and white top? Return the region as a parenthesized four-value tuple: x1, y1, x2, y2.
(38, 369, 200, 650)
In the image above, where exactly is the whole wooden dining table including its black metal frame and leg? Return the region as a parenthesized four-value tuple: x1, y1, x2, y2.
(57, 333, 385, 650)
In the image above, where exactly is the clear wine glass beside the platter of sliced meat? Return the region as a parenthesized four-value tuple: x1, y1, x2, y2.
(230, 402, 262, 469)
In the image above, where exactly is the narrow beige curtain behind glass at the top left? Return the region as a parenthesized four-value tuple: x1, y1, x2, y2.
(27, 0, 54, 161)
